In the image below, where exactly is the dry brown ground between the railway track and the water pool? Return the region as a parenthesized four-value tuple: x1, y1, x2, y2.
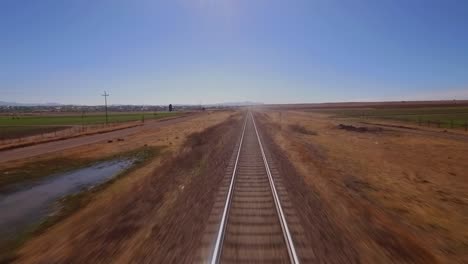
(10, 111, 241, 263)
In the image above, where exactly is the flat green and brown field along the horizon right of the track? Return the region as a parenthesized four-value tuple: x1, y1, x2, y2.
(326, 106, 468, 128)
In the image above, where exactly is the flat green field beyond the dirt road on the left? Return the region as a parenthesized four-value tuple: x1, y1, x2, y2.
(0, 112, 180, 140)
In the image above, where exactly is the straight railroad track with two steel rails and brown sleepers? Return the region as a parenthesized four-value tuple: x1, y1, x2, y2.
(210, 112, 299, 264)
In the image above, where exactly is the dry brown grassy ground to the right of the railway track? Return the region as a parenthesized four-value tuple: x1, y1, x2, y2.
(256, 110, 468, 263)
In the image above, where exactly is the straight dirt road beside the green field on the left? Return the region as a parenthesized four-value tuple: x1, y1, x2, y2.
(0, 114, 195, 163)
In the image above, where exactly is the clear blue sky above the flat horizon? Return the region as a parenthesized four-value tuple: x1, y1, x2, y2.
(0, 0, 468, 104)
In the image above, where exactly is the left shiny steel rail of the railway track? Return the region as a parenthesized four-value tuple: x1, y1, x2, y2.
(211, 114, 248, 264)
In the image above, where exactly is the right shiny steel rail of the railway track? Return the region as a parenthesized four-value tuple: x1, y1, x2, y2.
(249, 112, 300, 263)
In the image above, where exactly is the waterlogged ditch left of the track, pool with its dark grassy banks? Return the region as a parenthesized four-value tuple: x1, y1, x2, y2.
(0, 147, 161, 261)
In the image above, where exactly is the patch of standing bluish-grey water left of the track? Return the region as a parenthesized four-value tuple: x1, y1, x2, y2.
(0, 159, 135, 236)
